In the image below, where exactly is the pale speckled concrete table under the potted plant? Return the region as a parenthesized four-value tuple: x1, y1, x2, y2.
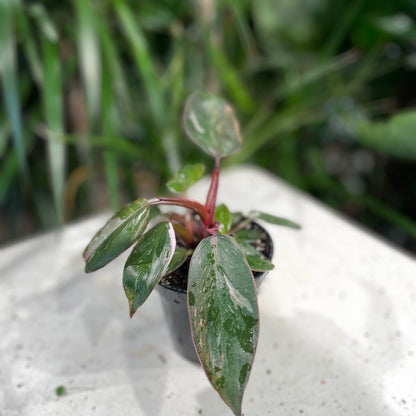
(0, 167, 416, 416)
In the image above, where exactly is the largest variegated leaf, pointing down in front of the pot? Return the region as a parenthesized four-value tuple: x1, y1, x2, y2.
(188, 234, 259, 416)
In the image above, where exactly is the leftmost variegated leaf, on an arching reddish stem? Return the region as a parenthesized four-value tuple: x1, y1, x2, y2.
(83, 198, 149, 273)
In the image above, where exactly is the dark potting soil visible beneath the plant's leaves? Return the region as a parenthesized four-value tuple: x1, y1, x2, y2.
(161, 222, 273, 291)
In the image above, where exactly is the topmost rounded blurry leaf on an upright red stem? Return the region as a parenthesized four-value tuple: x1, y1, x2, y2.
(184, 91, 242, 159)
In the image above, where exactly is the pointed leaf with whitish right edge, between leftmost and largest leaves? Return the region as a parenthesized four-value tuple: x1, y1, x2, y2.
(123, 222, 176, 317)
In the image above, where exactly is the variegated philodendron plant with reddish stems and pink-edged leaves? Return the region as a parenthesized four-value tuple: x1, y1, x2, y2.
(84, 92, 299, 416)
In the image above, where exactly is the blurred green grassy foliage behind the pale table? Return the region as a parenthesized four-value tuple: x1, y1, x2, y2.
(0, 0, 416, 252)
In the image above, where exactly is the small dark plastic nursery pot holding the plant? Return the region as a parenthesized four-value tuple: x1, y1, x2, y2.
(156, 222, 273, 363)
